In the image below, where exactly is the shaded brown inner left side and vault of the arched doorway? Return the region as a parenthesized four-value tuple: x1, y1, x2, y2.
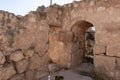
(71, 20, 94, 67)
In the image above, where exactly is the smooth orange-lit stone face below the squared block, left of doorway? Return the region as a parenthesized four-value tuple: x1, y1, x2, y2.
(49, 41, 72, 66)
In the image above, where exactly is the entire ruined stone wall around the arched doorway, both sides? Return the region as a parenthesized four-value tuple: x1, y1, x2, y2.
(0, 0, 120, 80)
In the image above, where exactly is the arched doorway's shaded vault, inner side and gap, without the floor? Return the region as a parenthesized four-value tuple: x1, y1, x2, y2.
(71, 20, 95, 67)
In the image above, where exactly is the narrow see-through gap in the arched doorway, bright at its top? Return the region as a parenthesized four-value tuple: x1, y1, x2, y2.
(84, 26, 95, 64)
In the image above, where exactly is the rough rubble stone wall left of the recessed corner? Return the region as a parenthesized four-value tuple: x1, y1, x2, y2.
(0, 11, 49, 80)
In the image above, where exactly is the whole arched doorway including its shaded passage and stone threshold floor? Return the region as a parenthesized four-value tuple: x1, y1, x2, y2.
(71, 20, 95, 78)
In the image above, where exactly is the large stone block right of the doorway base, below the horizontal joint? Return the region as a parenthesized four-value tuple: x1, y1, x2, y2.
(94, 55, 116, 80)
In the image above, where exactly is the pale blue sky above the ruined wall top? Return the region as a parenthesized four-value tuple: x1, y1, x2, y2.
(0, 0, 79, 15)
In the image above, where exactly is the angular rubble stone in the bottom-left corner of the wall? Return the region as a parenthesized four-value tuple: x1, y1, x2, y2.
(0, 64, 16, 80)
